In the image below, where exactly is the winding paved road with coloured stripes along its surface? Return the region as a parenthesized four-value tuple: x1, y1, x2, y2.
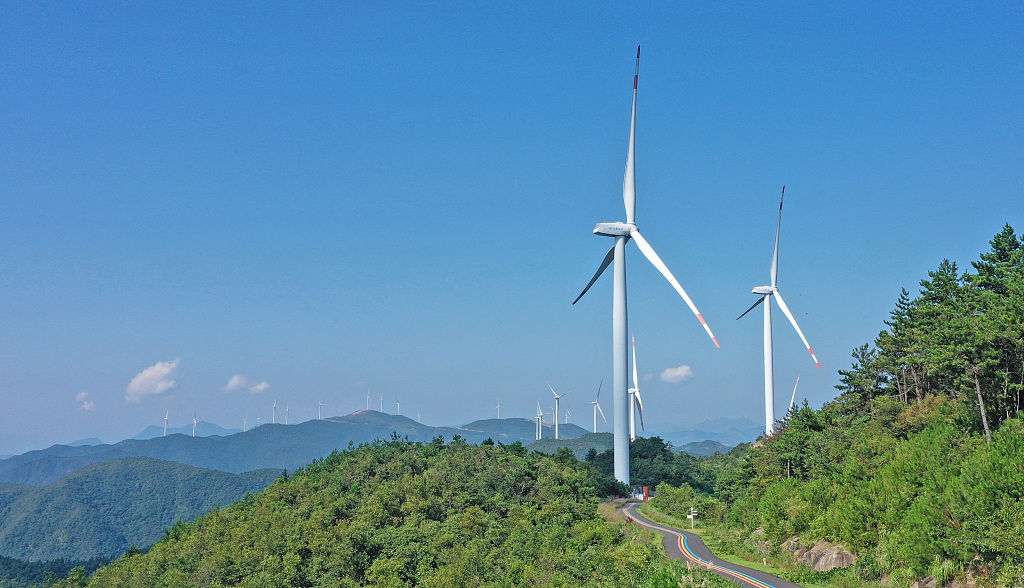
(620, 503, 803, 588)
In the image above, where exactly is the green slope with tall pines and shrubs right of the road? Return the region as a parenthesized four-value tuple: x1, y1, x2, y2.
(653, 225, 1024, 587)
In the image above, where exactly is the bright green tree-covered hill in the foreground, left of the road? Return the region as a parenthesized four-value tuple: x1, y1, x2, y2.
(48, 440, 724, 588)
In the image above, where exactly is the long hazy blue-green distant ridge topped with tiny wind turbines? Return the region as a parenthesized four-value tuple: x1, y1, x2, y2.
(0, 411, 586, 486)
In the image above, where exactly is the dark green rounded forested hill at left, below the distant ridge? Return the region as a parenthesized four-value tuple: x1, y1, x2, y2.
(0, 457, 281, 559)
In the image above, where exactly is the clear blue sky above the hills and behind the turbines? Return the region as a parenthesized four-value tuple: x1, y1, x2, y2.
(0, 2, 1024, 454)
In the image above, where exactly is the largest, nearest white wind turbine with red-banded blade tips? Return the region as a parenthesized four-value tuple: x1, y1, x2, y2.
(572, 47, 721, 485)
